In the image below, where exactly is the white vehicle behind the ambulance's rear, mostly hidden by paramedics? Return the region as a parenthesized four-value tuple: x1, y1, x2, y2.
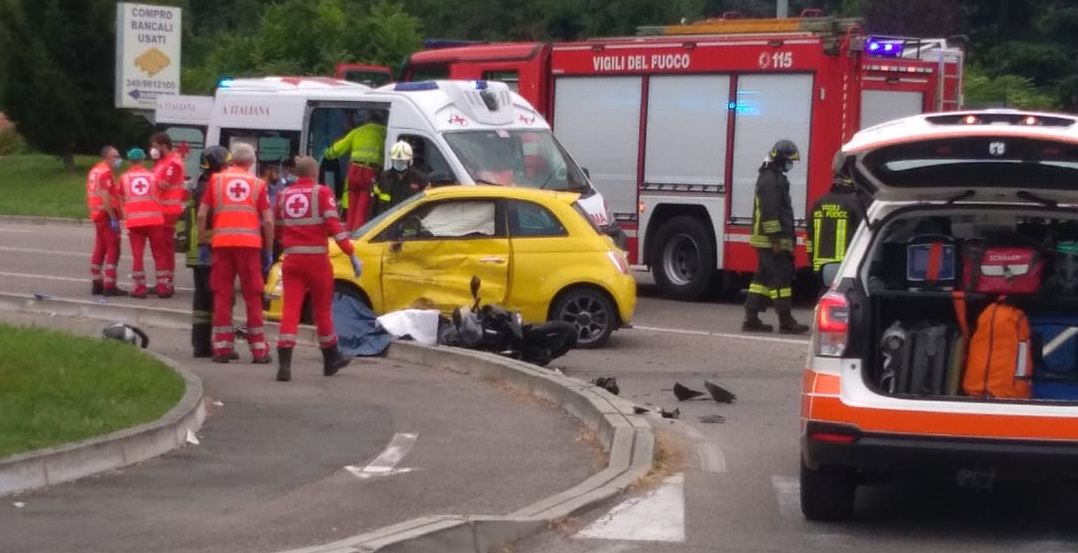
(153, 95, 213, 180)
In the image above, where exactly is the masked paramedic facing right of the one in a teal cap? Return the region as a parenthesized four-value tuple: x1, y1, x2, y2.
(150, 133, 189, 298)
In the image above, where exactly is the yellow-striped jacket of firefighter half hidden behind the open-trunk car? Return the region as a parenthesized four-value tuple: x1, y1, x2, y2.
(805, 178, 865, 271)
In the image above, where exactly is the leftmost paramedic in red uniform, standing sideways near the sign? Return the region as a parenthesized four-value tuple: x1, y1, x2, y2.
(86, 146, 127, 296)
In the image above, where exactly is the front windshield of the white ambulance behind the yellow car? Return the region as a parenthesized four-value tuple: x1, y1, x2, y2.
(445, 129, 590, 192)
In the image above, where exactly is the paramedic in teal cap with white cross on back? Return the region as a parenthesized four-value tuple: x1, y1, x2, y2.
(120, 148, 168, 299)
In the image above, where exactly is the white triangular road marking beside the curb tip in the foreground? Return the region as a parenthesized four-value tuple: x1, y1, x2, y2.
(576, 473, 685, 541)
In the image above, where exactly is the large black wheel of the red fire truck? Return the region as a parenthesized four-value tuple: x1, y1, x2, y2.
(650, 216, 715, 302)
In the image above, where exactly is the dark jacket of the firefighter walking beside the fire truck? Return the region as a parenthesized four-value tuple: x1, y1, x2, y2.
(748, 164, 797, 251)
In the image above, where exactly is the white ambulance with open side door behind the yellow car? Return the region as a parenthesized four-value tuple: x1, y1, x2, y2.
(206, 77, 624, 247)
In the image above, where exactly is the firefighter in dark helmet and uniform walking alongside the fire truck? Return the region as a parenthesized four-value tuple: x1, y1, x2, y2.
(742, 140, 809, 334)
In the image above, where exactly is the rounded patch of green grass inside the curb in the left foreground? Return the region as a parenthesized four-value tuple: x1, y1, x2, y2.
(0, 324, 184, 457)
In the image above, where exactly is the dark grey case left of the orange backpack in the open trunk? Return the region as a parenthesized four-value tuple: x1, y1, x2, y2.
(894, 322, 962, 396)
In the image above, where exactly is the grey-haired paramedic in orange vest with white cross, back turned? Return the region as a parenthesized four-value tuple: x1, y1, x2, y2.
(198, 143, 274, 364)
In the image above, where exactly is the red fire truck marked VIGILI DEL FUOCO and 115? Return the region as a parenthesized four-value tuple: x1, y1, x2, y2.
(340, 13, 964, 301)
